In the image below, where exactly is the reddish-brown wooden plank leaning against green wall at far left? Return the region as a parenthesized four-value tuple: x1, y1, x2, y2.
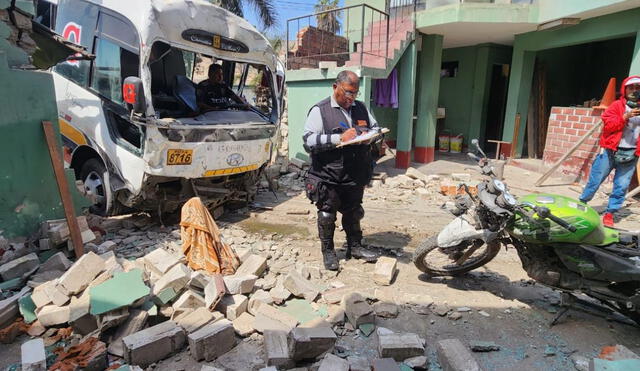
(42, 121, 84, 259)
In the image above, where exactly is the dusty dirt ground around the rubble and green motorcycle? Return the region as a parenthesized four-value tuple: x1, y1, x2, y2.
(0, 156, 640, 371)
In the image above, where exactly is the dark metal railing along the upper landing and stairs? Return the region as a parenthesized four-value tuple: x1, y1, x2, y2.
(286, 0, 416, 70)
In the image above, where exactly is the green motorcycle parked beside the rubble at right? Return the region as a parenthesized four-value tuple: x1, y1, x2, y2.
(413, 139, 640, 324)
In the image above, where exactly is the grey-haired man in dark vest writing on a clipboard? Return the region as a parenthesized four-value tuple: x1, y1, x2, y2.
(302, 71, 378, 270)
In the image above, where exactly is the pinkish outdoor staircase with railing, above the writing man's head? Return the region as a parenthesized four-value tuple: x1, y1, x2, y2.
(345, 16, 415, 71)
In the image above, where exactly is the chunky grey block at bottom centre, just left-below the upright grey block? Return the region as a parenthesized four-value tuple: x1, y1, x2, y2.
(289, 327, 338, 361)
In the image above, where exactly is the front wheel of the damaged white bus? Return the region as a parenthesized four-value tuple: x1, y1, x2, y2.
(80, 158, 114, 216)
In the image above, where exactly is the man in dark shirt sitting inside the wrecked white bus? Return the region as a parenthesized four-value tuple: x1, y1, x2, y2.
(197, 63, 246, 109)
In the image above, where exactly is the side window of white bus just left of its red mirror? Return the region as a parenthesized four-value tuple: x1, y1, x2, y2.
(91, 38, 139, 105)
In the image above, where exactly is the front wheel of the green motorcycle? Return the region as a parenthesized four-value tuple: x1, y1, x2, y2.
(413, 236, 500, 276)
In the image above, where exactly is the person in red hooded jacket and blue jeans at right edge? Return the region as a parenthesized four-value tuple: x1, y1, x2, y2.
(580, 76, 640, 227)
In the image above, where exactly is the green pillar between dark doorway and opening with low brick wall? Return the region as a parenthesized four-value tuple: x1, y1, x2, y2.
(502, 47, 536, 156)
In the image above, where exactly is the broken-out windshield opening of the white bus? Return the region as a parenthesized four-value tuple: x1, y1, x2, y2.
(149, 42, 277, 122)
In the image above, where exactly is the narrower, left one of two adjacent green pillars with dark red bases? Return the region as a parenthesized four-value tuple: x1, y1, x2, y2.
(396, 41, 417, 169)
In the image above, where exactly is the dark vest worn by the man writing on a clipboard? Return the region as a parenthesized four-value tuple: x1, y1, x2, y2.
(309, 97, 373, 186)
